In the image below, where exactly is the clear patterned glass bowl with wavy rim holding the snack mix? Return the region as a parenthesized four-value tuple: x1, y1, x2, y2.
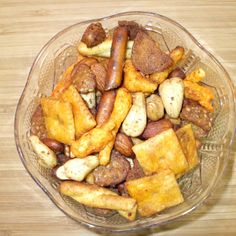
(15, 12, 235, 232)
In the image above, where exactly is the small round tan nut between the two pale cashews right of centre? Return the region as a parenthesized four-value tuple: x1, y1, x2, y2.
(146, 94, 164, 121)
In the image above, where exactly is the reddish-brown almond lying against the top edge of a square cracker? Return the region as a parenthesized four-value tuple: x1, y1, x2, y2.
(142, 119, 173, 139)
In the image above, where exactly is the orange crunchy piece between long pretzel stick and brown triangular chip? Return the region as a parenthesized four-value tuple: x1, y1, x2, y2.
(123, 60, 158, 93)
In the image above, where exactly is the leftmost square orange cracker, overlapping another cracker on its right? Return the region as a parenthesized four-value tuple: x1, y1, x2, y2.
(41, 98, 75, 145)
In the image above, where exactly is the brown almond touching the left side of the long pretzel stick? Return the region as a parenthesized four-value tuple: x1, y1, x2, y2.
(91, 63, 107, 93)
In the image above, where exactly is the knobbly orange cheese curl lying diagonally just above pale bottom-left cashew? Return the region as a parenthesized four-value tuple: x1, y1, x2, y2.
(71, 122, 115, 158)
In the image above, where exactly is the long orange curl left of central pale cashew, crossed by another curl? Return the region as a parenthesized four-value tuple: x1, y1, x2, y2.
(99, 88, 132, 165)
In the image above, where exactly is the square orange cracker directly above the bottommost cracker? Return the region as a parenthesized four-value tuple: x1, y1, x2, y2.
(132, 129, 188, 175)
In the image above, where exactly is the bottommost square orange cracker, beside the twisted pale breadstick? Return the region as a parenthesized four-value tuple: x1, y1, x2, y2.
(125, 170, 184, 216)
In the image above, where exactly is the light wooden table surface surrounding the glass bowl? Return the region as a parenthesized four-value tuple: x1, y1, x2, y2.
(0, 0, 236, 236)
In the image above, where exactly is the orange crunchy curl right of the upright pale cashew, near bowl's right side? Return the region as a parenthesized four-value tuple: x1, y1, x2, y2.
(184, 80, 215, 112)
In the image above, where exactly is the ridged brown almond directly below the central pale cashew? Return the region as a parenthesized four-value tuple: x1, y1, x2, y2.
(115, 133, 133, 157)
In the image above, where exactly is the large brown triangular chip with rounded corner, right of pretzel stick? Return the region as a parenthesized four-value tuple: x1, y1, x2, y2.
(131, 31, 173, 74)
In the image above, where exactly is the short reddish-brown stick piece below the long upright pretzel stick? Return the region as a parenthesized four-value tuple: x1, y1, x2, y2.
(96, 90, 116, 125)
